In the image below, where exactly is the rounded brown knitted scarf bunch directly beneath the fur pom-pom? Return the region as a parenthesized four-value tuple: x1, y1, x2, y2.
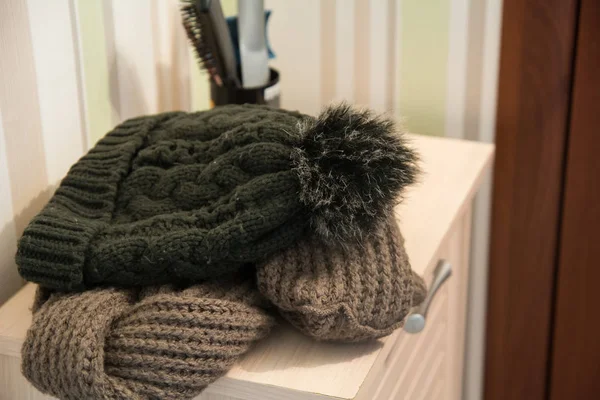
(257, 217, 426, 341)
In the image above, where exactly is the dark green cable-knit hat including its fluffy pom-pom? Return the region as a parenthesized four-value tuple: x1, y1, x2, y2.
(16, 105, 416, 290)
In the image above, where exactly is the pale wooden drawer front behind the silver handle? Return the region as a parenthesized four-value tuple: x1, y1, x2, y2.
(355, 206, 471, 400)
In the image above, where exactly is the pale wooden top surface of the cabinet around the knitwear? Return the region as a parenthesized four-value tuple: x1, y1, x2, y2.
(0, 135, 493, 399)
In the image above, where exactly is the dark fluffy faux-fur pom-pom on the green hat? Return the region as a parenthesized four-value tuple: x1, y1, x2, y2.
(293, 104, 418, 240)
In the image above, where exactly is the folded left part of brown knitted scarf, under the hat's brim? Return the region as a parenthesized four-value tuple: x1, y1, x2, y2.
(22, 280, 274, 400)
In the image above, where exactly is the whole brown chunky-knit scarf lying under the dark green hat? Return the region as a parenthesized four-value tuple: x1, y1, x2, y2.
(22, 217, 426, 400)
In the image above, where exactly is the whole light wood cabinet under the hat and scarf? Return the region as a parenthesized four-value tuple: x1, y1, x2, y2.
(0, 136, 493, 400)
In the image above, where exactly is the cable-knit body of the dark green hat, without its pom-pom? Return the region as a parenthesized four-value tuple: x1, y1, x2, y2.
(16, 105, 309, 290)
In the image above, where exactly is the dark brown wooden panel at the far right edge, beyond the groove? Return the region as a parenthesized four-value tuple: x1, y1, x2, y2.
(549, 0, 600, 400)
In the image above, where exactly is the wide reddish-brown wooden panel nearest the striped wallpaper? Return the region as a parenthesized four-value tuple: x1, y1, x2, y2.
(484, 0, 577, 400)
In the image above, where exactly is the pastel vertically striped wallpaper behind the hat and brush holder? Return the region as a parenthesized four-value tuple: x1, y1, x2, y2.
(0, 0, 500, 303)
